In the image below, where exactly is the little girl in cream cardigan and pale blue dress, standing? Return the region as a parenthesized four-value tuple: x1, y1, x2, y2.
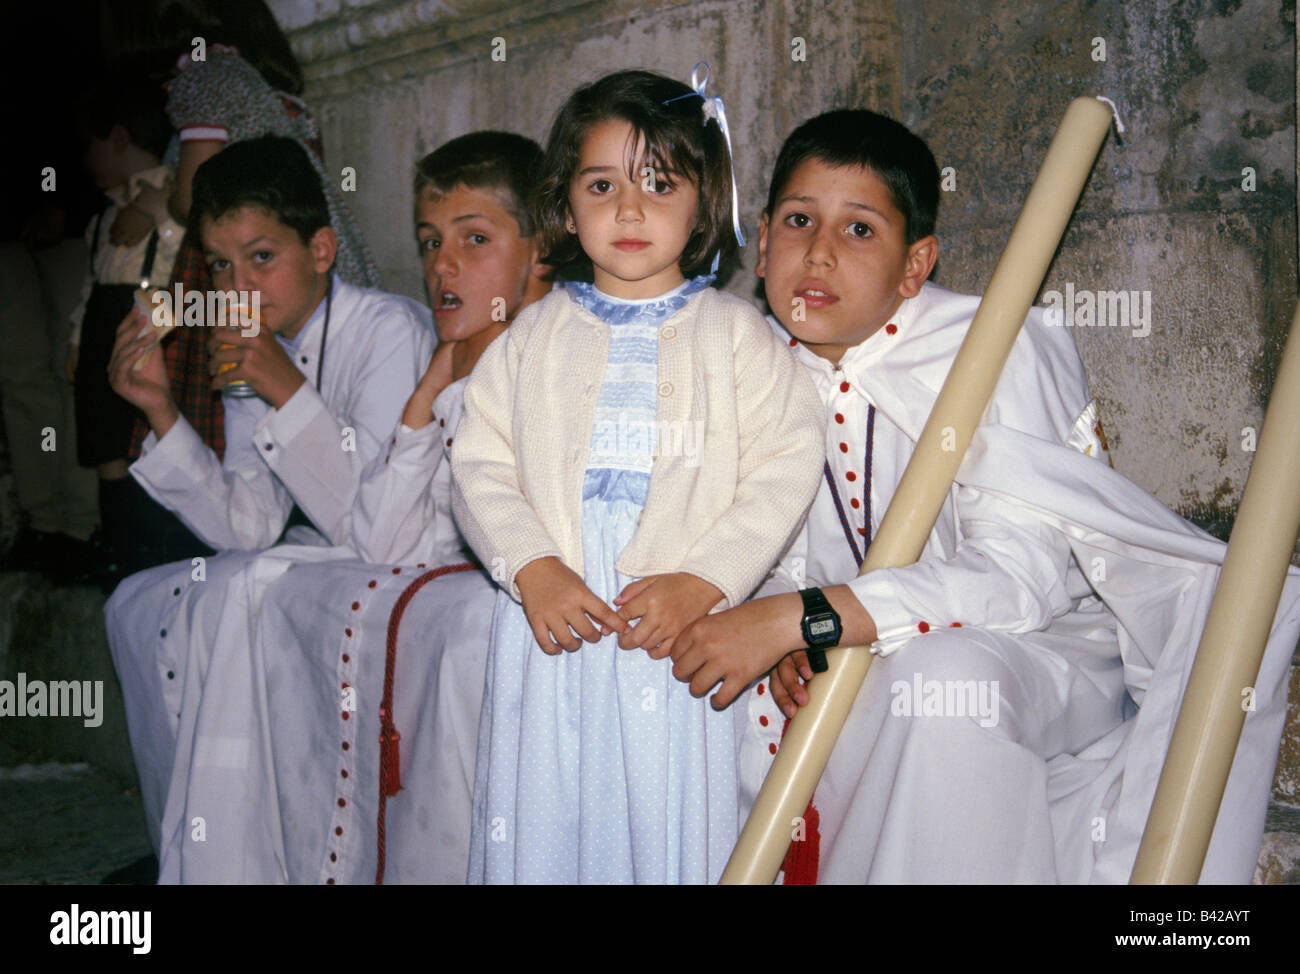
(451, 72, 823, 883)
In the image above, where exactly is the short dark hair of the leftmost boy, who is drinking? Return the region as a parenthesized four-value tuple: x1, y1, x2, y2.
(190, 135, 330, 243)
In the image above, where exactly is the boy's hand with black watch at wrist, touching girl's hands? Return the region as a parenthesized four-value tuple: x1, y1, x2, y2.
(651, 594, 803, 713)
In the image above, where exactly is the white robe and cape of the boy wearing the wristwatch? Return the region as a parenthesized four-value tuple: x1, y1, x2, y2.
(736, 283, 1300, 883)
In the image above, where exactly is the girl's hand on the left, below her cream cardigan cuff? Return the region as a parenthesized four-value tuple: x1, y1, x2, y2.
(515, 558, 628, 655)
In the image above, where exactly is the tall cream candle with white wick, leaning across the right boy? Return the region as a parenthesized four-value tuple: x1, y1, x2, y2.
(722, 98, 1112, 883)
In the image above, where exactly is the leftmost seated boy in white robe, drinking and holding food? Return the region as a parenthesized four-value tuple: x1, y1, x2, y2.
(104, 137, 433, 879)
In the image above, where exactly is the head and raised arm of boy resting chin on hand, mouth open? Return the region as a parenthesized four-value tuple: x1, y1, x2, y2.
(351, 131, 551, 564)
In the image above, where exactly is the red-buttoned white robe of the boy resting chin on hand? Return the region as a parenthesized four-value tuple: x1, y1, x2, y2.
(256, 380, 495, 884)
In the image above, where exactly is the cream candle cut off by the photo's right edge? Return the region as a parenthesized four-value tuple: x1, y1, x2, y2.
(1130, 304, 1300, 883)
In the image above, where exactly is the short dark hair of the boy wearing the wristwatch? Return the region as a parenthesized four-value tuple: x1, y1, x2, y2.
(766, 108, 939, 243)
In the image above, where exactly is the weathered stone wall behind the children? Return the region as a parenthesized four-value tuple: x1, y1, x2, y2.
(272, 0, 1296, 531)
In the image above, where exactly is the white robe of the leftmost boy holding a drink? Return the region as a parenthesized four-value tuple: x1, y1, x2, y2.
(104, 278, 433, 882)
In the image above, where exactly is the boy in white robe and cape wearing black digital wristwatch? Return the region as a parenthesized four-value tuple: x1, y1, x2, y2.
(672, 111, 1300, 883)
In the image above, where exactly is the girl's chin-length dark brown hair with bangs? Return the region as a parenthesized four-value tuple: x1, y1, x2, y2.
(533, 72, 736, 277)
